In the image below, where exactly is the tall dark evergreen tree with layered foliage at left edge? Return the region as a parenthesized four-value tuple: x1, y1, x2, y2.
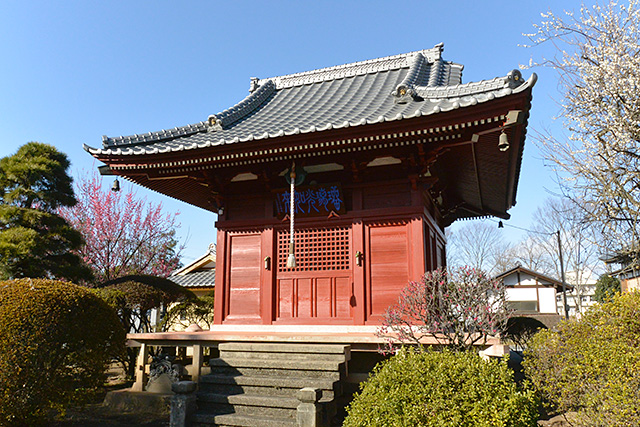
(0, 142, 91, 281)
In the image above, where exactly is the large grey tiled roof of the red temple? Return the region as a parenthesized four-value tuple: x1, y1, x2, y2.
(85, 44, 536, 156)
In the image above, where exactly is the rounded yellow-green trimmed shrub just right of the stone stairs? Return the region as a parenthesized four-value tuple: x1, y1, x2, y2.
(344, 349, 538, 427)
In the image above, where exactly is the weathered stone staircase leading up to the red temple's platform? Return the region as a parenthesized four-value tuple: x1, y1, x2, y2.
(190, 342, 351, 427)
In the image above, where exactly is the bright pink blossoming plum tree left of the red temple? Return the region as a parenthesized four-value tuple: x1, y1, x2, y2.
(60, 173, 183, 283)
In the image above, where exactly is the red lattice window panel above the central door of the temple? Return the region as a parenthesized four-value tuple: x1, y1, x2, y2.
(278, 227, 351, 271)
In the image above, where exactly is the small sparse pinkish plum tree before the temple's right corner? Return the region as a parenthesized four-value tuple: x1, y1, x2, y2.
(377, 267, 511, 350)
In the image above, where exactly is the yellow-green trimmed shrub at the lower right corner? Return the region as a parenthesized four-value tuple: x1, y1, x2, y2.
(524, 292, 640, 427)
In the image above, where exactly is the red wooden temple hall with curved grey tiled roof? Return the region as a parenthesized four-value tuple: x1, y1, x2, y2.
(85, 45, 536, 325)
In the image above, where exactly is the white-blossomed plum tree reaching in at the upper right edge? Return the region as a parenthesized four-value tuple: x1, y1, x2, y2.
(529, 0, 640, 262)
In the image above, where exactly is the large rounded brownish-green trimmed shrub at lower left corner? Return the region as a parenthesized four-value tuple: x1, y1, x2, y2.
(0, 279, 125, 425)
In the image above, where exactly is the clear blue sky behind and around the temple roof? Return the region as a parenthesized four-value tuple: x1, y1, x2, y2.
(0, 0, 580, 263)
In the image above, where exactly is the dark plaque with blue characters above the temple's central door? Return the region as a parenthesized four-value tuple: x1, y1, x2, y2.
(275, 184, 346, 217)
